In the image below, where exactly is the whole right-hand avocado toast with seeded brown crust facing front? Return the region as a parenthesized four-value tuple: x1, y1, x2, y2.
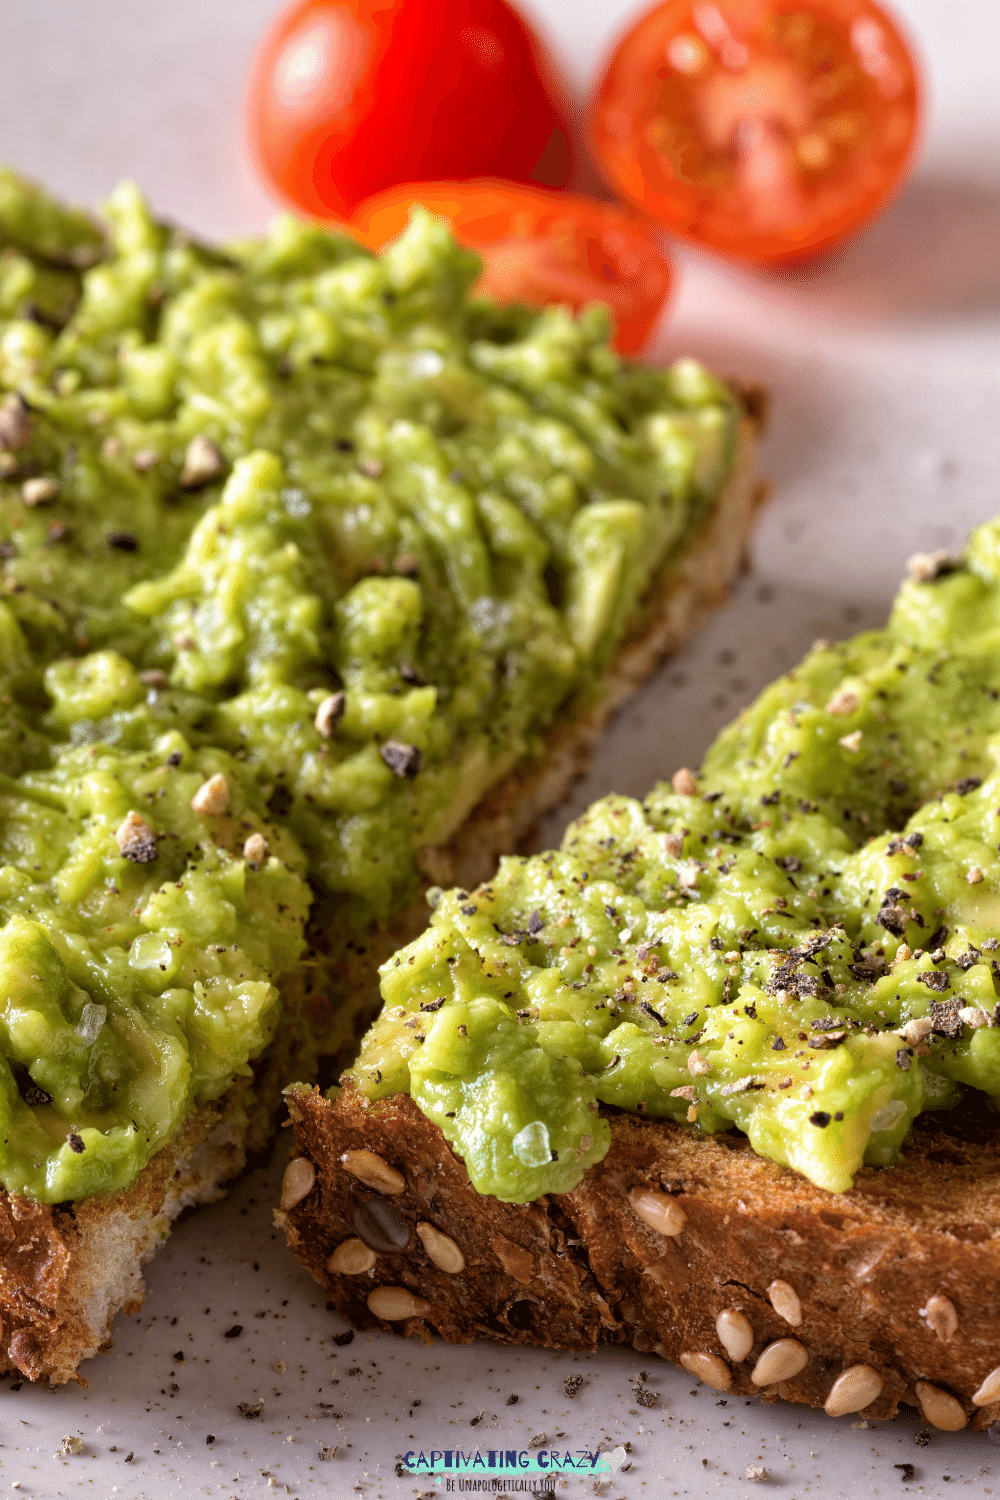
(279, 522, 1000, 1430)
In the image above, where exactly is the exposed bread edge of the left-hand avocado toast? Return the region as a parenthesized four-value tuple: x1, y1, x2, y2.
(0, 411, 763, 1385)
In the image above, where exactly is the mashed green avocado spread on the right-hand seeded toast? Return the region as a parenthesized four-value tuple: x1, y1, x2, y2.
(354, 521, 1000, 1202)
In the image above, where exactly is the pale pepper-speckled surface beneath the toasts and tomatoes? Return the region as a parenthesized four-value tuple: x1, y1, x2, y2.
(0, 0, 1000, 1500)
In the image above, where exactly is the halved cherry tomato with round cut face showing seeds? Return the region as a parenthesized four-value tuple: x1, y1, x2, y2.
(591, 0, 919, 263)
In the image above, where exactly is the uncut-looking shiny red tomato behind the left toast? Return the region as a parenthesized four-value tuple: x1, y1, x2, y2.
(247, 0, 570, 218)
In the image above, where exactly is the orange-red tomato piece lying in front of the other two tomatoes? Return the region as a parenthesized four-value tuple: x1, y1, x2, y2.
(351, 179, 670, 354)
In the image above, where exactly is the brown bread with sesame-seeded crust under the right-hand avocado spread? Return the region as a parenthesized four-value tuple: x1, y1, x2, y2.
(276, 1085, 1000, 1431)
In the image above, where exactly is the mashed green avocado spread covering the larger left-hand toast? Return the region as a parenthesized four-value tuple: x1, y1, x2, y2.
(0, 171, 734, 1202)
